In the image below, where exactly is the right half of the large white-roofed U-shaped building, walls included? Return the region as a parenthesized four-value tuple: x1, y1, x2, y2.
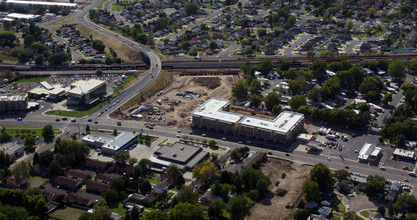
(239, 111, 304, 144)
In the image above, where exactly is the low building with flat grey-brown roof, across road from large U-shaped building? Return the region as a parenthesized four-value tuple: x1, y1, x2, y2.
(149, 142, 209, 171)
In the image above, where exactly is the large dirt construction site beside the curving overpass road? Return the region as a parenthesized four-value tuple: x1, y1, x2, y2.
(124, 75, 240, 128)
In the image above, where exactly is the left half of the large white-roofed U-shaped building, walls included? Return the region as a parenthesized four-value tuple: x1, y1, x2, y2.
(191, 98, 243, 134)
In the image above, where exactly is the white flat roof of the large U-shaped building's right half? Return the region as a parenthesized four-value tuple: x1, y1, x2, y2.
(239, 111, 304, 134)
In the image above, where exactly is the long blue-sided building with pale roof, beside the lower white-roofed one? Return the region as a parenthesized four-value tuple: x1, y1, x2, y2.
(101, 132, 138, 155)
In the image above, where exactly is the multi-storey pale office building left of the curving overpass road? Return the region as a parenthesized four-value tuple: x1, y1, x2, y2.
(67, 79, 106, 105)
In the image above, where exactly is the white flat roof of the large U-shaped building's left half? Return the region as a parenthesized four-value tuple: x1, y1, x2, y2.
(191, 98, 243, 123)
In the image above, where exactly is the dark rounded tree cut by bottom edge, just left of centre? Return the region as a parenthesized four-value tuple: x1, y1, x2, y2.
(168, 203, 209, 220)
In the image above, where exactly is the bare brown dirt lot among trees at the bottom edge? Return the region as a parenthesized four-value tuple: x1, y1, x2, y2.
(248, 158, 312, 220)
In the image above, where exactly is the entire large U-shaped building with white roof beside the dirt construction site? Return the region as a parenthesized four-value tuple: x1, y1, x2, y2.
(191, 98, 304, 144)
